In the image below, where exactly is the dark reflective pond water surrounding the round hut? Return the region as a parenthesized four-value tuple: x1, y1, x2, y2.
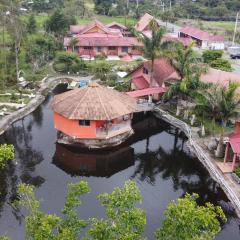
(0, 86, 240, 240)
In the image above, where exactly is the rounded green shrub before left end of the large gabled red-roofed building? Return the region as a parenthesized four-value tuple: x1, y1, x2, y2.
(54, 52, 86, 73)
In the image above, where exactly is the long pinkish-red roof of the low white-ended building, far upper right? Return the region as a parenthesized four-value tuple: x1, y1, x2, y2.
(179, 26, 224, 42)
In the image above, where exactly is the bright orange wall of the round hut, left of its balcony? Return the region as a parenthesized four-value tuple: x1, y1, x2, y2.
(54, 113, 96, 139)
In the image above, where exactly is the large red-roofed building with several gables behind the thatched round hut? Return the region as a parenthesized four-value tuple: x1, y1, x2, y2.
(64, 20, 141, 58)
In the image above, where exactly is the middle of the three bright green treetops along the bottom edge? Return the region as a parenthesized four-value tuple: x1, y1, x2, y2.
(87, 181, 146, 240)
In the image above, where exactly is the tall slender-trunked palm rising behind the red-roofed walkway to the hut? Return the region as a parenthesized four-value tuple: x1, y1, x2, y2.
(136, 20, 166, 87)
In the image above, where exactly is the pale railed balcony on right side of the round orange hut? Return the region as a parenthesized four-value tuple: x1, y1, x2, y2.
(96, 120, 132, 139)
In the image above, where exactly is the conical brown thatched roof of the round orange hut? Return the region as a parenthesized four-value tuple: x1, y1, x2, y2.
(51, 83, 137, 120)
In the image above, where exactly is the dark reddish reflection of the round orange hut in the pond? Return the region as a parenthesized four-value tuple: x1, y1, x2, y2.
(53, 143, 134, 177)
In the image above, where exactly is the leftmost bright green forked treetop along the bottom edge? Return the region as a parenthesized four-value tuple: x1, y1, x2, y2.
(18, 181, 90, 240)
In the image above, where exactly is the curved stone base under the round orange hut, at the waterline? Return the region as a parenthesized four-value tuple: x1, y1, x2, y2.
(57, 129, 134, 149)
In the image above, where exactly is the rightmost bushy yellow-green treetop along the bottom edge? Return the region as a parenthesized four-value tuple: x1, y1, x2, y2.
(156, 194, 226, 240)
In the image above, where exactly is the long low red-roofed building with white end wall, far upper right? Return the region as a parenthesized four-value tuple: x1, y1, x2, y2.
(179, 26, 225, 50)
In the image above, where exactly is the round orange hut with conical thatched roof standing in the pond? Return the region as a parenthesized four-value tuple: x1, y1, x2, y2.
(51, 83, 137, 148)
